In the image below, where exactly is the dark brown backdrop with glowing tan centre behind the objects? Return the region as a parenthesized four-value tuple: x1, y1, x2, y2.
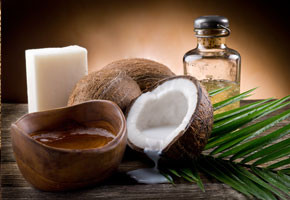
(1, 0, 290, 102)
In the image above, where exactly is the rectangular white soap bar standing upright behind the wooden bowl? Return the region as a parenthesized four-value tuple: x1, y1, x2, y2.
(25, 46, 88, 112)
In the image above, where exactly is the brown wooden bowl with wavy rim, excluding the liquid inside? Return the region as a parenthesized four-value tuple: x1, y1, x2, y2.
(11, 100, 127, 191)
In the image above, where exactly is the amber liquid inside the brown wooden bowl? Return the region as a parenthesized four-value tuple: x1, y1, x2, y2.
(30, 122, 116, 149)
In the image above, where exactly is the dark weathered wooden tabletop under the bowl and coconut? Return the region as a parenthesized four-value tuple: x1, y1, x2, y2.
(0, 101, 290, 200)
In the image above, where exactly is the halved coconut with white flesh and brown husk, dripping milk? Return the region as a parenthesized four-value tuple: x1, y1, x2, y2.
(127, 76, 213, 160)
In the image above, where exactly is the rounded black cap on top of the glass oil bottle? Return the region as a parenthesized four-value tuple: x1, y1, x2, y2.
(194, 15, 229, 29)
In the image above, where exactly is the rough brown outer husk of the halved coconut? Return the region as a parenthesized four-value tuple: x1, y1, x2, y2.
(126, 76, 213, 161)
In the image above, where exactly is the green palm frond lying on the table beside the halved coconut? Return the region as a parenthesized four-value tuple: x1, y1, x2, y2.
(161, 87, 290, 199)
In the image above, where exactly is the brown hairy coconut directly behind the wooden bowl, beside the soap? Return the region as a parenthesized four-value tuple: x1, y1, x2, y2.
(68, 71, 141, 111)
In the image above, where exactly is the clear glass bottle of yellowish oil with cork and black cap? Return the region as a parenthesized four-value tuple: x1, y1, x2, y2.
(183, 15, 241, 114)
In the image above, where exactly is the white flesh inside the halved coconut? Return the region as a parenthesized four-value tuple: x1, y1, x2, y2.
(127, 78, 198, 151)
